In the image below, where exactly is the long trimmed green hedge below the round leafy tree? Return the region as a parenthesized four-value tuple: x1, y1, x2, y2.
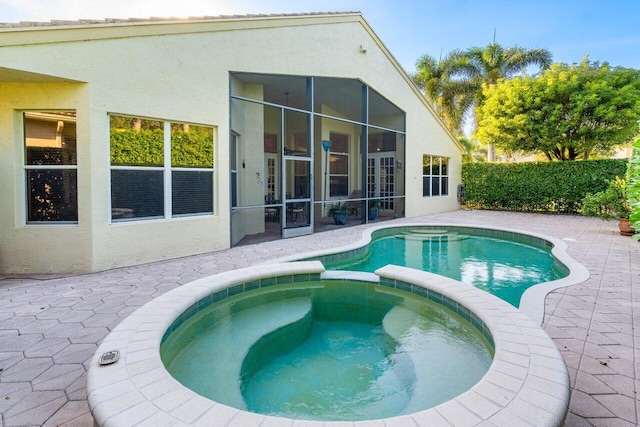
(462, 159, 627, 213)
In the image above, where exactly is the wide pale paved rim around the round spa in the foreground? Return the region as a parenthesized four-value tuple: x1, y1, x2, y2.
(87, 261, 570, 427)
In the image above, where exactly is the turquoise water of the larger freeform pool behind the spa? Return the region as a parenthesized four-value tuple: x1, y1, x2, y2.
(314, 227, 568, 307)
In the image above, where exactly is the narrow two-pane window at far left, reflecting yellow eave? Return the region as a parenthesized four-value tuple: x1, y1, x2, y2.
(23, 111, 78, 223)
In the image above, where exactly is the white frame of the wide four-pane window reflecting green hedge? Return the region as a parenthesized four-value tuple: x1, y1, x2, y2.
(107, 113, 217, 224)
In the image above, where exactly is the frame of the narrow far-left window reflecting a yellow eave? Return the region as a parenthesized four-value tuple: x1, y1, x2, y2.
(19, 108, 80, 226)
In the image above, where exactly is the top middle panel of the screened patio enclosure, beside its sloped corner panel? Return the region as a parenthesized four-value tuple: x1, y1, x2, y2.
(313, 77, 365, 122)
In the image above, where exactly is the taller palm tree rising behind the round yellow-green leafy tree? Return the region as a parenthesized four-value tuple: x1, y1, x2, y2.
(449, 42, 552, 161)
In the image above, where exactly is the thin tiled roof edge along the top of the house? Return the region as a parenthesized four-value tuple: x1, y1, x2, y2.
(0, 12, 360, 28)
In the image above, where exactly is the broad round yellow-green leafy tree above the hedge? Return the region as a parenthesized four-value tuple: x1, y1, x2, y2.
(476, 58, 640, 160)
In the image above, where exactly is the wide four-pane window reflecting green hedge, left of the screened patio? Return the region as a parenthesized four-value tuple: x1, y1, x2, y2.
(110, 115, 213, 221)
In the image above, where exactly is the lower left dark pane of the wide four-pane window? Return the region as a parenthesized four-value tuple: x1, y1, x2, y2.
(111, 170, 164, 221)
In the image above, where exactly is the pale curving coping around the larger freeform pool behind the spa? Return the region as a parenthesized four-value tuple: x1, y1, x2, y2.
(264, 222, 590, 325)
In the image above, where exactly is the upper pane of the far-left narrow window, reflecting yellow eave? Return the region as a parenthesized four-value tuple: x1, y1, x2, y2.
(24, 112, 77, 165)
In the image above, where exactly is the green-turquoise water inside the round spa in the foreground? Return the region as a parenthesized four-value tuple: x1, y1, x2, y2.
(161, 280, 493, 421)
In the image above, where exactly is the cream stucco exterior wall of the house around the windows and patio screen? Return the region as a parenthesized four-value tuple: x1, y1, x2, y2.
(0, 14, 460, 273)
